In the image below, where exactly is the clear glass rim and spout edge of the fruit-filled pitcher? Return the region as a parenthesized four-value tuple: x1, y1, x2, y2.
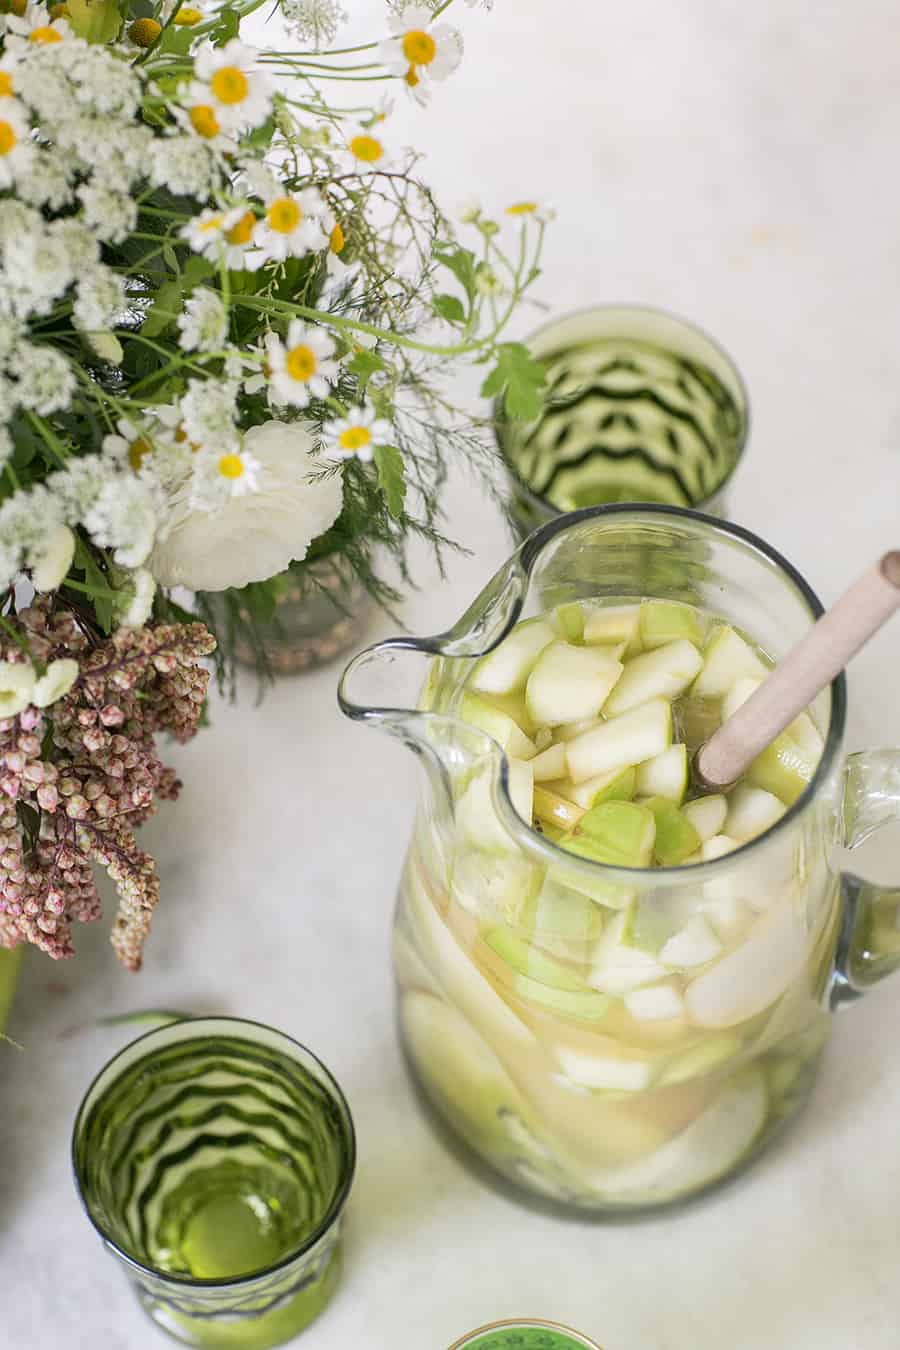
(337, 502, 847, 886)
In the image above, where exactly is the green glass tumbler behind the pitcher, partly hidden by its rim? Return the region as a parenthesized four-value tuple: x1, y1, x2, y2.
(495, 305, 749, 536)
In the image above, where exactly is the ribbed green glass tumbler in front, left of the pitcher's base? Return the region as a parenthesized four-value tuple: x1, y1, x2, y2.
(73, 1018, 356, 1350)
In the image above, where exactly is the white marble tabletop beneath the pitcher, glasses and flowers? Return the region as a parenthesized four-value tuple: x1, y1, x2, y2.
(0, 0, 900, 1350)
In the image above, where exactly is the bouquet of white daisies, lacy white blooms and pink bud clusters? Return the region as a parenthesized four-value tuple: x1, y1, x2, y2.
(0, 0, 546, 969)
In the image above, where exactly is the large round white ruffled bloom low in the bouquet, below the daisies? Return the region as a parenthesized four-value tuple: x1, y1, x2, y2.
(148, 421, 343, 591)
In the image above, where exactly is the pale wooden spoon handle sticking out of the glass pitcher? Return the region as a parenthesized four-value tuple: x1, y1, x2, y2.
(694, 551, 900, 792)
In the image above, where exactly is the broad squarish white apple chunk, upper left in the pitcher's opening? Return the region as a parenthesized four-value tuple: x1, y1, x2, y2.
(525, 643, 623, 726)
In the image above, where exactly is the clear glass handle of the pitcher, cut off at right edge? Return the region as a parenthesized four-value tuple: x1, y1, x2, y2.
(831, 749, 900, 1007)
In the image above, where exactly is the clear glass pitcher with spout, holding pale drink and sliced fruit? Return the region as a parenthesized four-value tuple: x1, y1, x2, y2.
(340, 506, 900, 1212)
